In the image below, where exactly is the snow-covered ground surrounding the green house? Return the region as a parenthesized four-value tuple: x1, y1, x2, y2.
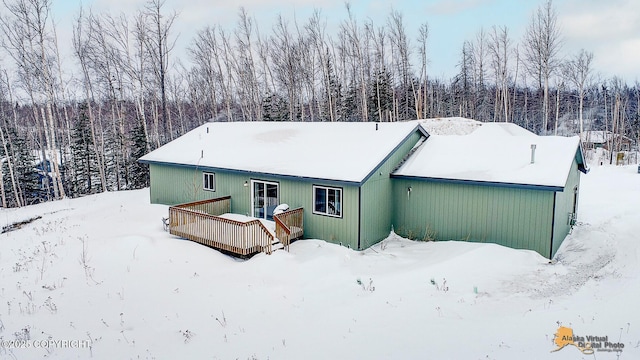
(0, 166, 640, 360)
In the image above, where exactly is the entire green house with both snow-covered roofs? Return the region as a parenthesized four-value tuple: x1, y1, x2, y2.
(140, 121, 584, 257)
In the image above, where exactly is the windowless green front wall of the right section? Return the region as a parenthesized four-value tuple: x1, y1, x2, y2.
(393, 179, 554, 257)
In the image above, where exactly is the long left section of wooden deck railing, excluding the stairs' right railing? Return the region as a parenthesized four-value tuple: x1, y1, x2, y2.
(169, 196, 274, 255)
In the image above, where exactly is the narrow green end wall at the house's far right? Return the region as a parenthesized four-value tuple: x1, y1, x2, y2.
(546, 160, 580, 257)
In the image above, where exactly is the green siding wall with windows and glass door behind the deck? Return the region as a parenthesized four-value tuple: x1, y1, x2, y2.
(150, 164, 359, 248)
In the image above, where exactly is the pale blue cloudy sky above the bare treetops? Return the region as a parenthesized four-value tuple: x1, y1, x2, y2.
(53, 0, 640, 83)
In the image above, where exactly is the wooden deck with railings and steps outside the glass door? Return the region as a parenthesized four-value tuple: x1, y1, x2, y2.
(169, 196, 304, 256)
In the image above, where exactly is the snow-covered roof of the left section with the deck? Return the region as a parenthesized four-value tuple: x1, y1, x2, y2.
(140, 122, 422, 183)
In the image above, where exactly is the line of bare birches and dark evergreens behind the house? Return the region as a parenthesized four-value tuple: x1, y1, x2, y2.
(0, 0, 640, 207)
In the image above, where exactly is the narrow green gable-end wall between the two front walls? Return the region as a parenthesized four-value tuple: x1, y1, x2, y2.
(360, 131, 422, 249)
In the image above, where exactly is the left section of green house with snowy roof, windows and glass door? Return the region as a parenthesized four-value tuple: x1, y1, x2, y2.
(140, 122, 427, 249)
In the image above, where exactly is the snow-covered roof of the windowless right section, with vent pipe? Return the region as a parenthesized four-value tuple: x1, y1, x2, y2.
(393, 123, 580, 188)
